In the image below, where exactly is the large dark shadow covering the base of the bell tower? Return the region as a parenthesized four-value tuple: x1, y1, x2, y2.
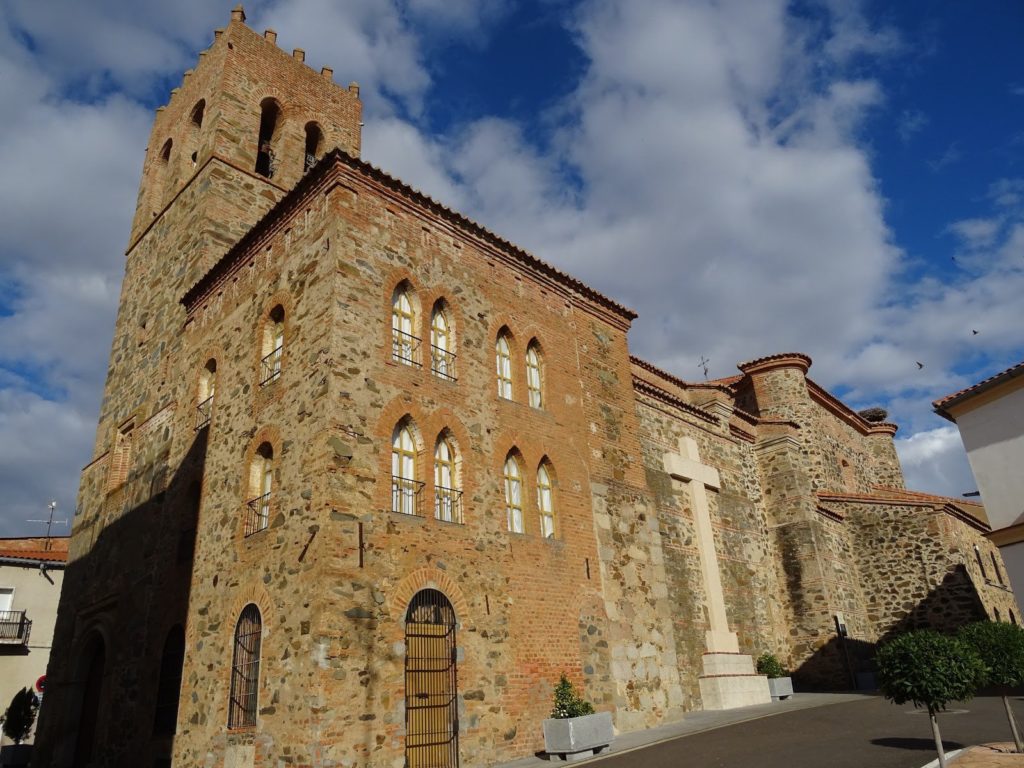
(33, 428, 208, 768)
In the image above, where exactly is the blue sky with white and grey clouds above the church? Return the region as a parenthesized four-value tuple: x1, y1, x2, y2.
(0, 0, 1024, 536)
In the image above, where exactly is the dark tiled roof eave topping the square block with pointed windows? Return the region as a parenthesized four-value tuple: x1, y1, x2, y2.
(180, 148, 637, 323)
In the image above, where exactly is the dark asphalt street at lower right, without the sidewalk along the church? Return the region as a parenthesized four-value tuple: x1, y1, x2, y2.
(599, 697, 1024, 768)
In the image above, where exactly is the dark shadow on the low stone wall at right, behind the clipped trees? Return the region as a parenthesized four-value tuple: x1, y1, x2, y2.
(793, 564, 988, 691)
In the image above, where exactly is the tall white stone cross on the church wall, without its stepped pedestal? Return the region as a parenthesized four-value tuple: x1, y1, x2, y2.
(664, 437, 739, 653)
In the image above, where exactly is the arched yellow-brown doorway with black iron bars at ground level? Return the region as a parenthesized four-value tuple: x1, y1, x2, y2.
(406, 589, 459, 768)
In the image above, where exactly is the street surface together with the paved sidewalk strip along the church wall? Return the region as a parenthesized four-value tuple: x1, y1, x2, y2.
(485, 693, 1024, 768)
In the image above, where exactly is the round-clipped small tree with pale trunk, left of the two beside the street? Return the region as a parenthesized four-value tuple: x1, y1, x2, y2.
(874, 630, 985, 768)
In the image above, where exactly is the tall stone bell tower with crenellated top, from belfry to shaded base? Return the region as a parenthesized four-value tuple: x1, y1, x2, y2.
(36, 6, 361, 766)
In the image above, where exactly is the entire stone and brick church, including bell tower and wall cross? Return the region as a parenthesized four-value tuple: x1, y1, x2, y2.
(37, 9, 1018, 768)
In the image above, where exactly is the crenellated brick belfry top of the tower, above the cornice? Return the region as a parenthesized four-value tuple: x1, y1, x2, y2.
(129, 5, 362, 250)
